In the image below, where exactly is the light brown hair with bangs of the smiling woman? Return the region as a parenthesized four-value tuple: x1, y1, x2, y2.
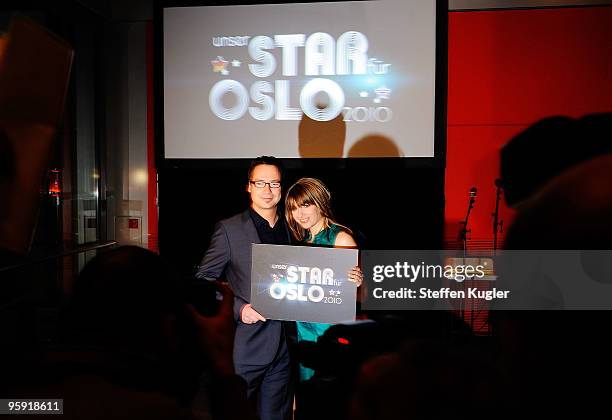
(285, 178, 351, 242)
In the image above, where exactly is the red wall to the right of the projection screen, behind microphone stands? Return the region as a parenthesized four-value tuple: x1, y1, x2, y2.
(446, 7, 612, 248)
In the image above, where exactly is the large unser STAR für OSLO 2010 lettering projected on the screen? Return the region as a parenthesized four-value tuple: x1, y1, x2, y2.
(208, 31, 393, 122)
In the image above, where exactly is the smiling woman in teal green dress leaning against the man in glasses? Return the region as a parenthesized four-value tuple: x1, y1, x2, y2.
(285, 178, 363, 381)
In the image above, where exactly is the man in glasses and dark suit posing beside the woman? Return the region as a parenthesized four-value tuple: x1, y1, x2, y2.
(196, 156, 293, 420)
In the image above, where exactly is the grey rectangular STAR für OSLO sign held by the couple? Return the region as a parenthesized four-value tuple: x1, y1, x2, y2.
(251, 244, 359, 324)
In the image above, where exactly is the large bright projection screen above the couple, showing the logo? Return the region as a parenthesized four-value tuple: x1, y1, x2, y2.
(163, 0, 436, 159)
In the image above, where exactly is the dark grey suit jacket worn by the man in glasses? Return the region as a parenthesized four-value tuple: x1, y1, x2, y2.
(196, 209, 289, 365)
